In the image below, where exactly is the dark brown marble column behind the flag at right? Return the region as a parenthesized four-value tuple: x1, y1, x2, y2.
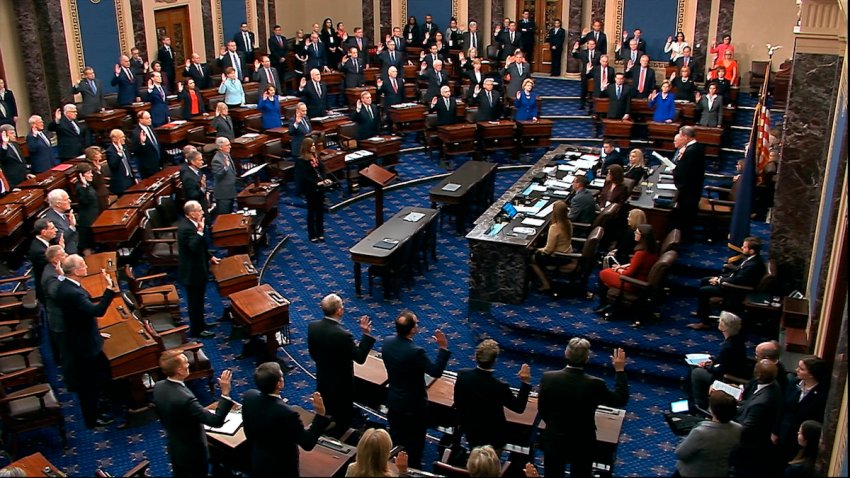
(770, 51, 843, 291)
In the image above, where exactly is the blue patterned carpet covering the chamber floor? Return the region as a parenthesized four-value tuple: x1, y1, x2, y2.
(14, 78, 780, 476)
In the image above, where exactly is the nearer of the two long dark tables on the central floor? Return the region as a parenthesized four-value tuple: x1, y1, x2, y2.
(348, 206, 437, 296)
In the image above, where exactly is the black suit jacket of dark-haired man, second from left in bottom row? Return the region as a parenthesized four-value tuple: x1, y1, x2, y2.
(242, 390, 330, 477)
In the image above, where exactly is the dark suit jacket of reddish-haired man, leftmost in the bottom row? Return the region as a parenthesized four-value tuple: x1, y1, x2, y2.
(153, 379, 233, 476)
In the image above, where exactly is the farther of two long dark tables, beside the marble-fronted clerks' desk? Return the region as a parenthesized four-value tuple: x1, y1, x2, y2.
(429, 161, 496, 234)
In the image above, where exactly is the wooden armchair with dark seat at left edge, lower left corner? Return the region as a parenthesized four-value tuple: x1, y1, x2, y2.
(0, 368, 68, 455)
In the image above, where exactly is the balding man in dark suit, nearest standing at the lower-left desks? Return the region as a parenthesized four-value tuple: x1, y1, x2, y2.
(56, 254, 119, 428)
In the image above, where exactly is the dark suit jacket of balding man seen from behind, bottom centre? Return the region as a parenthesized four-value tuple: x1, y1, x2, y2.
(382, 335, 451, 415)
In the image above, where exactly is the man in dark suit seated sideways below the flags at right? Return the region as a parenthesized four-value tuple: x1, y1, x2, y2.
(692, 235, 765, 330)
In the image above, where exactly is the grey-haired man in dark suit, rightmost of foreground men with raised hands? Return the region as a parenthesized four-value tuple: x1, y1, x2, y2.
(537, 337, 629, 478)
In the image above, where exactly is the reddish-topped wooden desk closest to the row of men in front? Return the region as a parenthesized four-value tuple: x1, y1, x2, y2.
(230, 284, 289, 360)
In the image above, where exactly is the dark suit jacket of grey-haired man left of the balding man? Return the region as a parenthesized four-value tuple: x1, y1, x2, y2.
(299, 320, 375, 426)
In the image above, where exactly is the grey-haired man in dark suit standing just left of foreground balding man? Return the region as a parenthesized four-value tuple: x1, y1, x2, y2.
(307, 294, 375, 436)
